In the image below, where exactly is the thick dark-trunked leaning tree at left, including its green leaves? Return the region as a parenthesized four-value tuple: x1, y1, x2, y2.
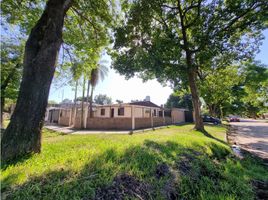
(1, 0, 114, 160)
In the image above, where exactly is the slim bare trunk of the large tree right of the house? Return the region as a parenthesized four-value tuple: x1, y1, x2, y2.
(188, 69, 205, 132)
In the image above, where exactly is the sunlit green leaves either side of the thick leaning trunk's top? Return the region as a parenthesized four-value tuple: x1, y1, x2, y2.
(1, 0, 118, 87)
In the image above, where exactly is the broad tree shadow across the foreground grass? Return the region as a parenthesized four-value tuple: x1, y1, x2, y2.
(2, 140, 268, 200)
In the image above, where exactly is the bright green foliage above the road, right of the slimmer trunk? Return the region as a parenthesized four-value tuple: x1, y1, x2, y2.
(199, 61, 268, 117)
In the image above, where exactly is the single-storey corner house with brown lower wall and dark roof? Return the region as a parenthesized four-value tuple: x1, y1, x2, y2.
(47, 98, 191, 130)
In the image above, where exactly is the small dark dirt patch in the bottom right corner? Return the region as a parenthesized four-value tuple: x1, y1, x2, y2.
(251, 180, 268, 200)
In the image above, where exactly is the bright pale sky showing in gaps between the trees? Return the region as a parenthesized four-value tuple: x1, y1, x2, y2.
(49, 30, 268, 105)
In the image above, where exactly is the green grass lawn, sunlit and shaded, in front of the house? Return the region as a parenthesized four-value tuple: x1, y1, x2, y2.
(1, 124, 268, 200)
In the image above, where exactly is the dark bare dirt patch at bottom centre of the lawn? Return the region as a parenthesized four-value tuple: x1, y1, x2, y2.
(95, 174, 151, 200)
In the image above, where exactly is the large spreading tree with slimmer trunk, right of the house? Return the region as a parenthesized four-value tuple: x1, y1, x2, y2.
(112, 0, 267, 131)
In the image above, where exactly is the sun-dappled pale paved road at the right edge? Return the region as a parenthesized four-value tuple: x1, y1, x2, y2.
(230, 119, 268, 160)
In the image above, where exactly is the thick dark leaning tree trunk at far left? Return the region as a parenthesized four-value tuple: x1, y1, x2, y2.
(1, 0, 71, 160)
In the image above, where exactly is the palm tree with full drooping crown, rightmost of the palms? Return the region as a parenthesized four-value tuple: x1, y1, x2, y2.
(87, 64, 109, 118)
